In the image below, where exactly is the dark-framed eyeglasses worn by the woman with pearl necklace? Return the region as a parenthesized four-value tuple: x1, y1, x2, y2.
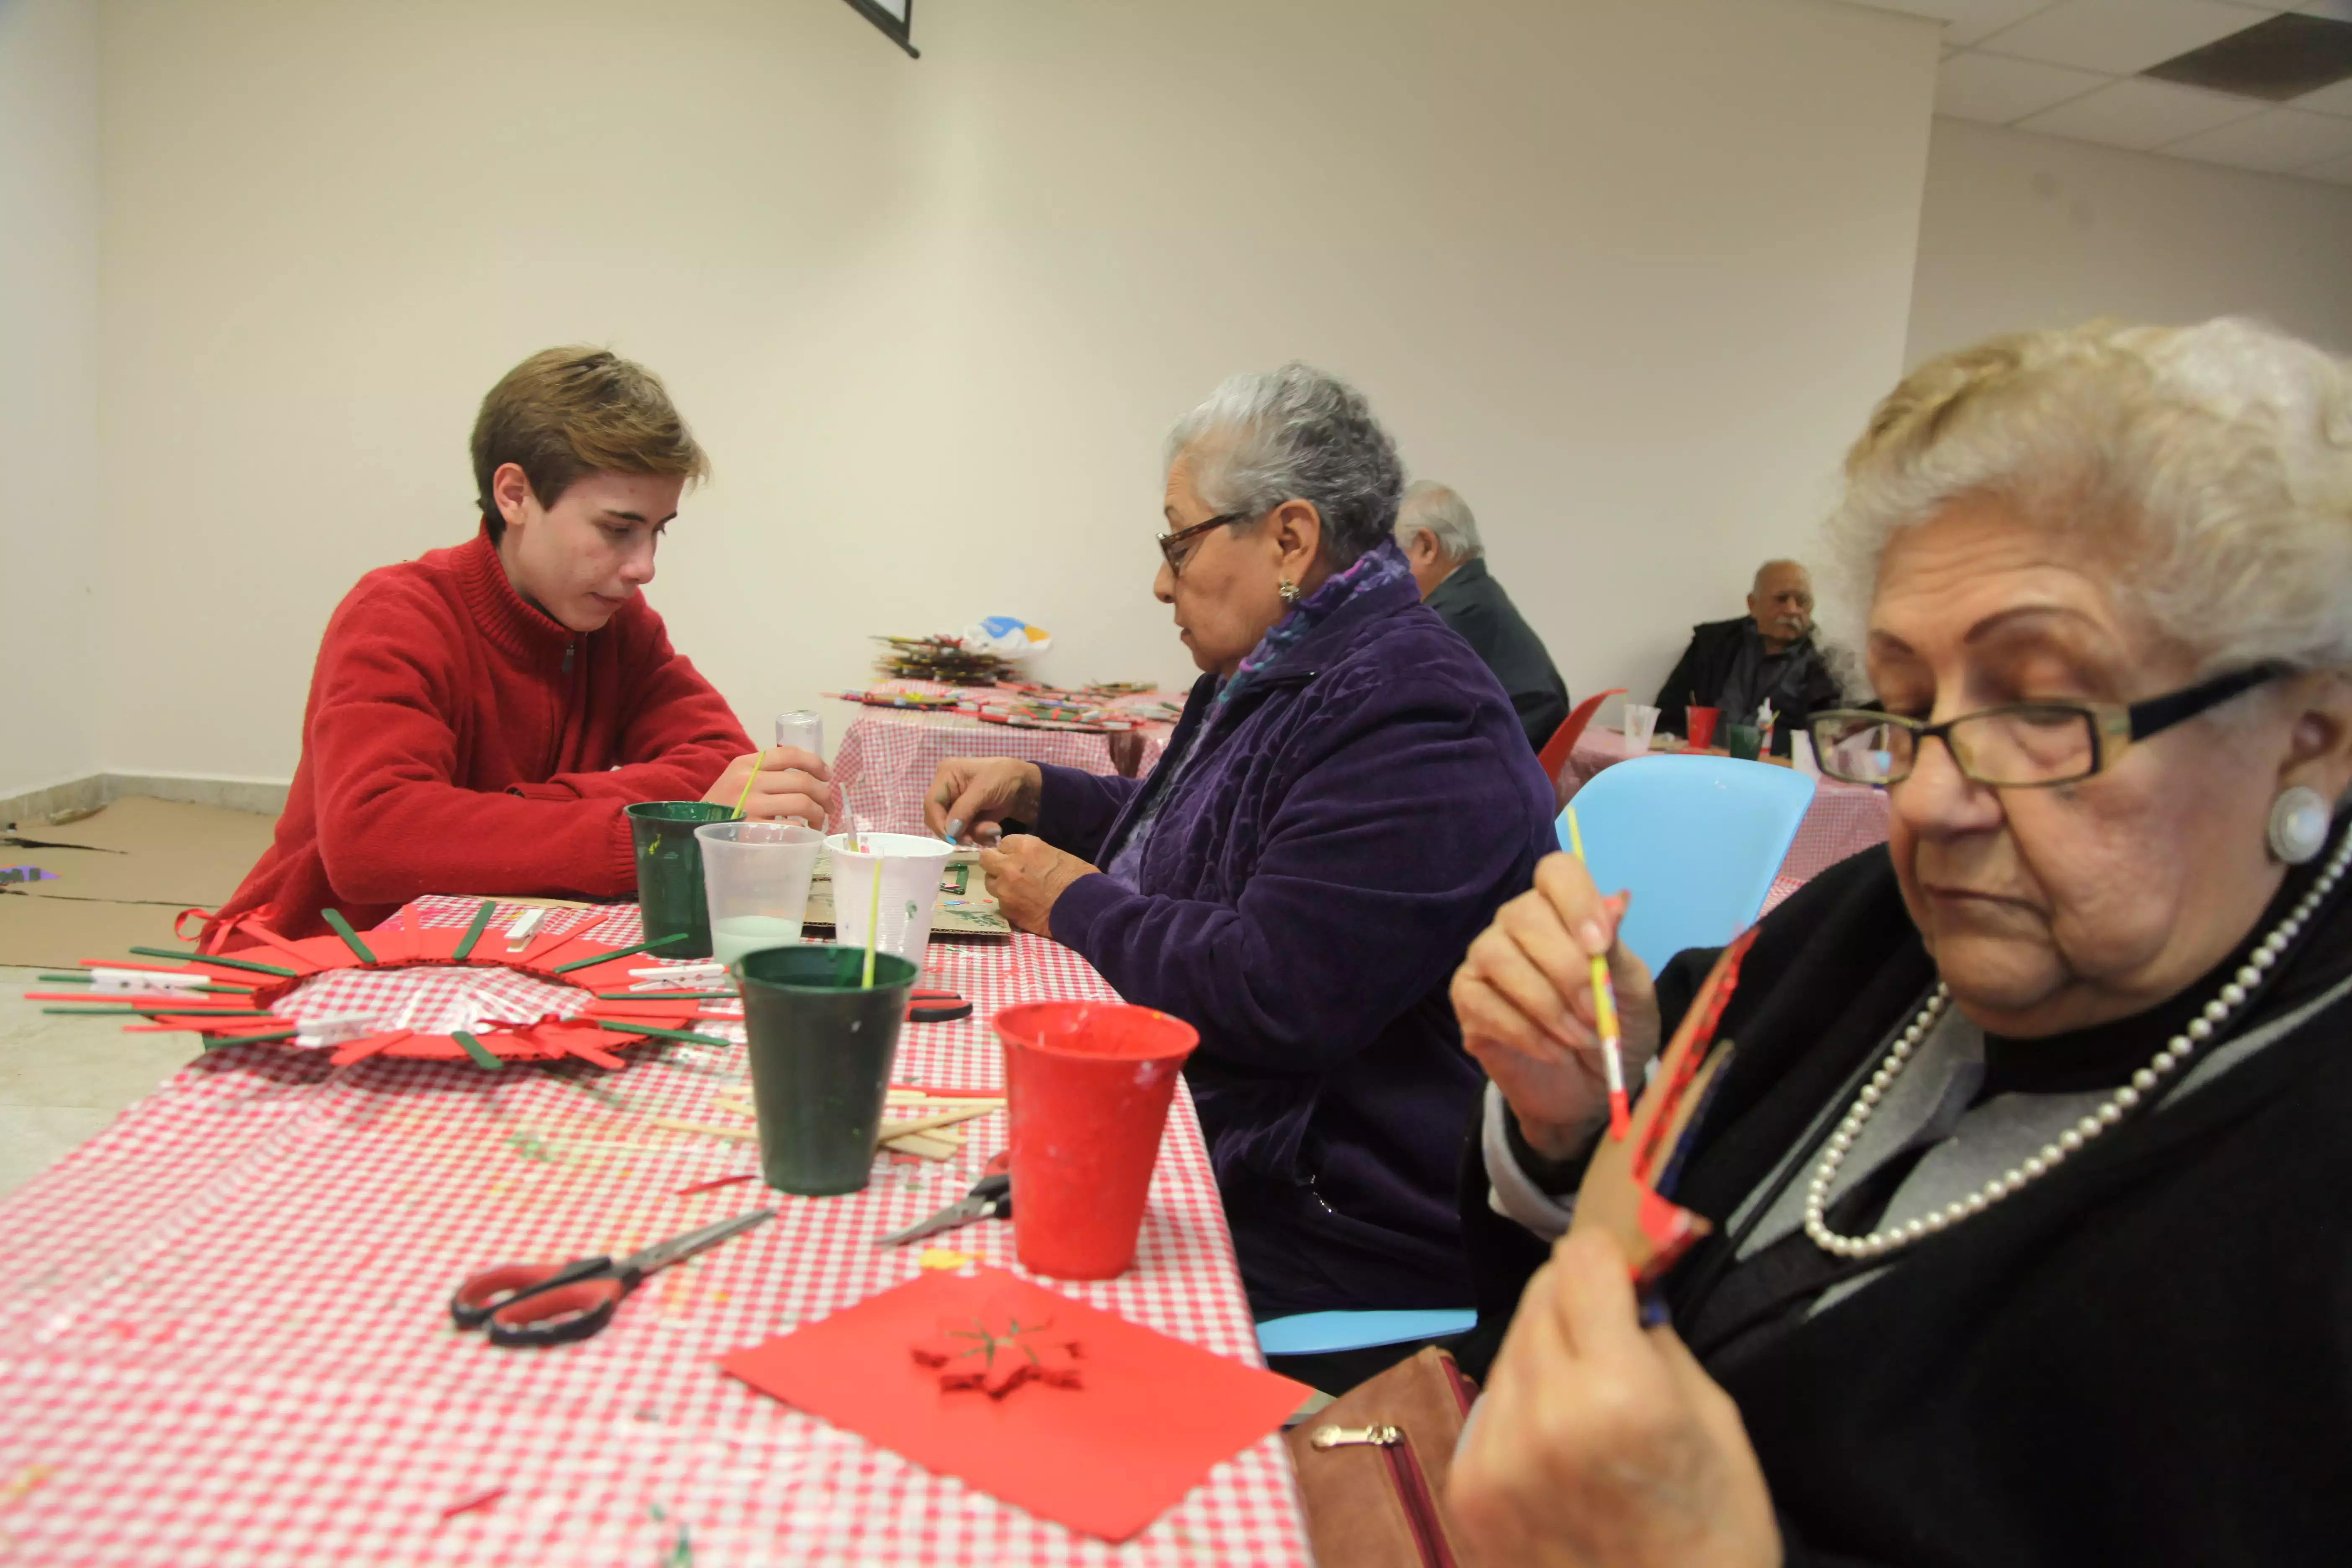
(1806, 663, 2293, 790)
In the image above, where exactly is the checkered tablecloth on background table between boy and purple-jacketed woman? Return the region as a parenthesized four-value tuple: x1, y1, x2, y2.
(833, 682, 1183, 832)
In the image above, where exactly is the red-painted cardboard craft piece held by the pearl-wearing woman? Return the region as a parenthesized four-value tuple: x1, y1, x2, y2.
(1569, 926, 1755, 1286)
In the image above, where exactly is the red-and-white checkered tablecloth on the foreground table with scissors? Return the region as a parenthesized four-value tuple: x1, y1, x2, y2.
(0, 898, 1308, 1568)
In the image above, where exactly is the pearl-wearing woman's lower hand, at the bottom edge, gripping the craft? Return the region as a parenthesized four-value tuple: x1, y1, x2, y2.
(1447, 1232, 1780, 1568)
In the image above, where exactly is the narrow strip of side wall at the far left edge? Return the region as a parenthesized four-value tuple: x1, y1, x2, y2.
(0, 0, 99, 794)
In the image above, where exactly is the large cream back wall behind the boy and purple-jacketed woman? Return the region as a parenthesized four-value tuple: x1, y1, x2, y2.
(101, 0, 1936, 776)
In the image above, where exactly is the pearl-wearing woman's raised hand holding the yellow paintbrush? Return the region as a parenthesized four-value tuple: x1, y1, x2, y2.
(1454, 854, 1658, 1159)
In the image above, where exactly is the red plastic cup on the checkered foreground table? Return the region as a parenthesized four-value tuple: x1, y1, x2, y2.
(995, 1001, 1199, 1279)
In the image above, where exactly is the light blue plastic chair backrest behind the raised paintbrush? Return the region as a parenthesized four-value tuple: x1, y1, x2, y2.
(1559, 757, 1813, 971)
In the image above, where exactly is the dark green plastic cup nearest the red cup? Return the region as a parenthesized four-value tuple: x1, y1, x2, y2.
(734, 945, 917, 1197)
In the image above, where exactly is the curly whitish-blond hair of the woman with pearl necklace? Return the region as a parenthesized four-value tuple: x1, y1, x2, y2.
(1828, 317, 2352, 672)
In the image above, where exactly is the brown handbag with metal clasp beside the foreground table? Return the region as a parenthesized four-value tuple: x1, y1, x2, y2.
(1284, 1345, 1477, 1568)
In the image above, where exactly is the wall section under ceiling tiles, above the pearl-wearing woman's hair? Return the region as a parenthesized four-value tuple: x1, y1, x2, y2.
(1908, 120, 2352, 364)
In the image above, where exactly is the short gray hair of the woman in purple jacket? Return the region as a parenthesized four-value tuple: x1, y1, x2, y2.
(1167, 360, 1404, 571)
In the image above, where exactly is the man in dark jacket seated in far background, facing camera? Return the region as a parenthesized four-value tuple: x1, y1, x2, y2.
(1658, 562, 1844, 757)
